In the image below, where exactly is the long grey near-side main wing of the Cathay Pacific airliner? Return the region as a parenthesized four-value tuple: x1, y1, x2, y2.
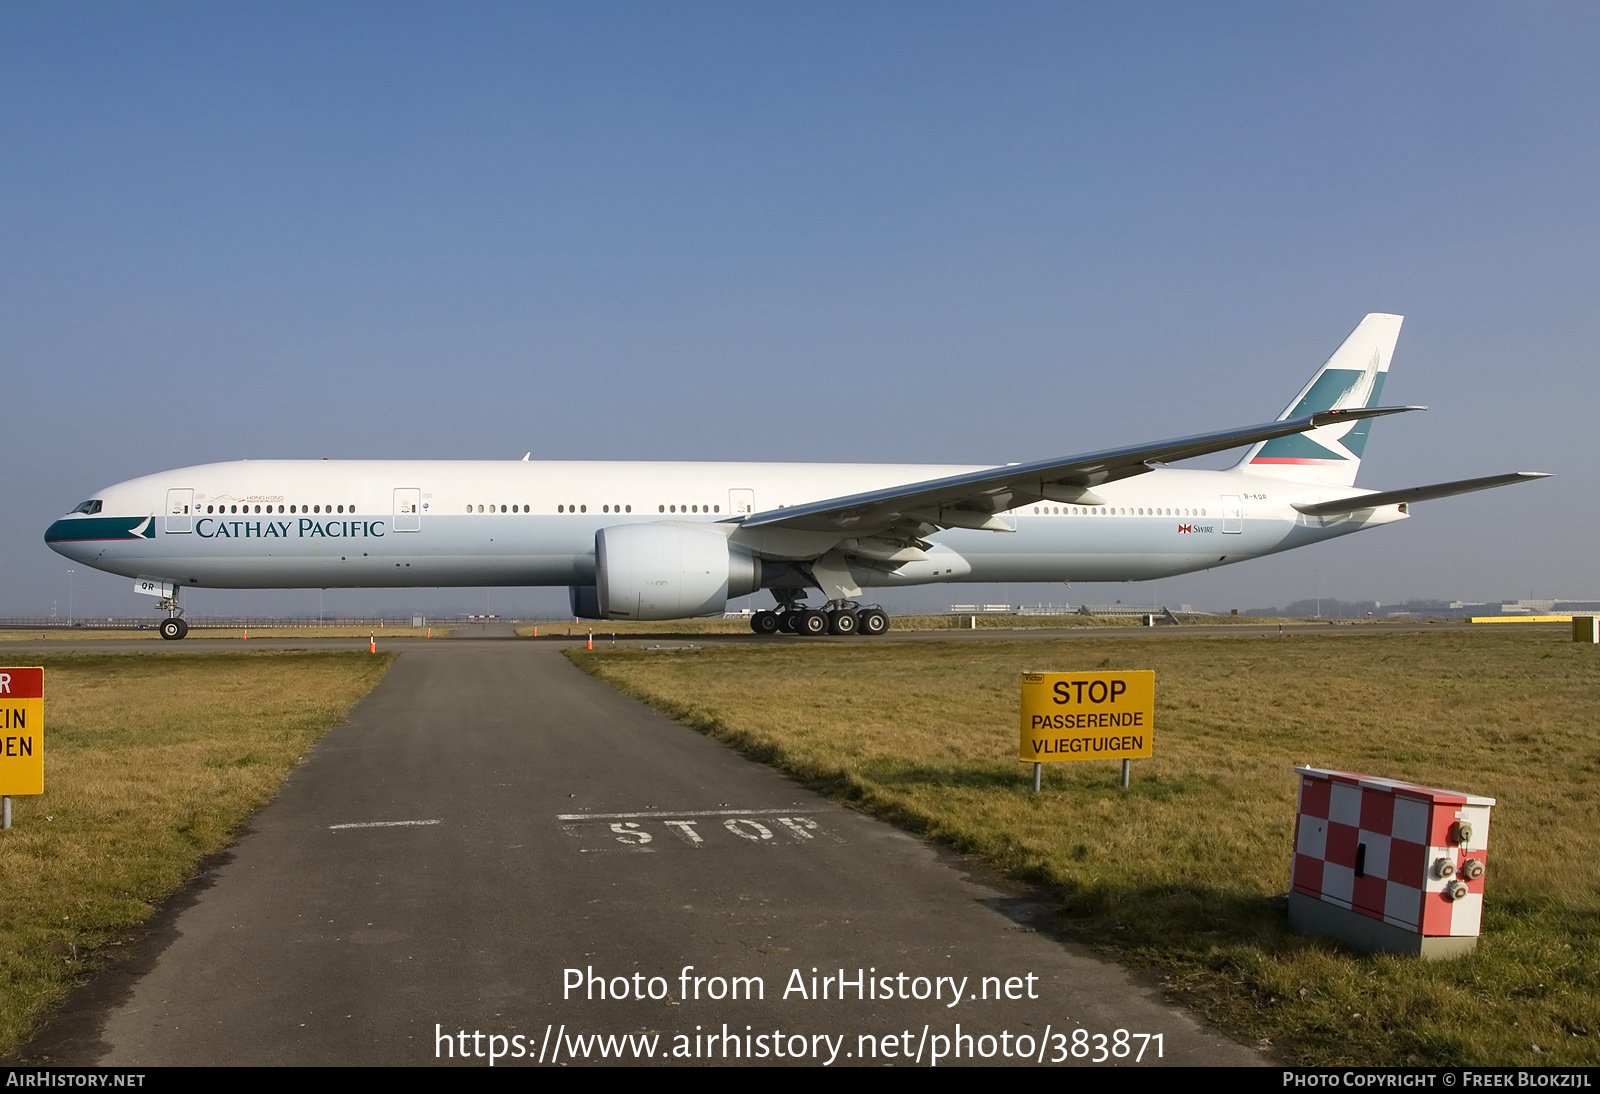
(742, 406, 1426, 536)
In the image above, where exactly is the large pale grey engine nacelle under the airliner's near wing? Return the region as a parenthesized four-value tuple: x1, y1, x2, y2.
(595, 523, 762, 619)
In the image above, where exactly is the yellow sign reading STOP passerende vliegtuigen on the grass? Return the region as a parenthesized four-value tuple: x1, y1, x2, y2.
(1022, 669, 1155, 763)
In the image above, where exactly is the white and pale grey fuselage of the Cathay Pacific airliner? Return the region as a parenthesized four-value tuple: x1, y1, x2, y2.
(45, 461, 1405, 589)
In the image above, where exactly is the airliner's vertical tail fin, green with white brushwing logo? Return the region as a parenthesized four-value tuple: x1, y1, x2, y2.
(1234, 312, 1405, 486)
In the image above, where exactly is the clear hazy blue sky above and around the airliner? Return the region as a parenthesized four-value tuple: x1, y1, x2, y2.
(0, 3, 1600, 616)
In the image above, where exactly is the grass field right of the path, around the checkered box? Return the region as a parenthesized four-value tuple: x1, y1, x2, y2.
(570, 627, 1600, 1064)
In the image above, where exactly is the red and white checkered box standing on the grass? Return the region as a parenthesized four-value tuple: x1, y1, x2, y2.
(1290, 768, 1494, 948)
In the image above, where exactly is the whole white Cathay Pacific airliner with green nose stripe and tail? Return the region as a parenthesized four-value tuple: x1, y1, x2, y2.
(45, 313, 1544, 638)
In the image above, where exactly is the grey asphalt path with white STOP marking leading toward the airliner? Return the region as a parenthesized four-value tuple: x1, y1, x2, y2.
(13, 632, 1266, 1067)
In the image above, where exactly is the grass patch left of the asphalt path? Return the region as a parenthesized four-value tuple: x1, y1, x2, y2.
(0, 651, 392, 1059)
